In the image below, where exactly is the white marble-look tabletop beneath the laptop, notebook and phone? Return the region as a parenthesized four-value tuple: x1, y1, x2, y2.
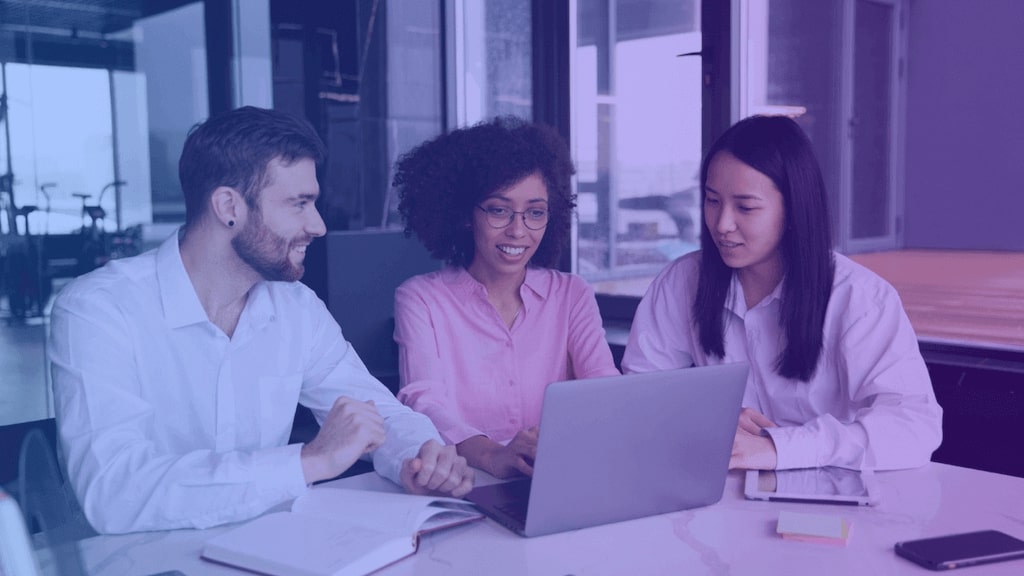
(81, 463, 1024, 576)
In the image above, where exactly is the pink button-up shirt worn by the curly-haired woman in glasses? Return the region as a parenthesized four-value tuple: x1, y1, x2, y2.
(394, 266, 618, 444)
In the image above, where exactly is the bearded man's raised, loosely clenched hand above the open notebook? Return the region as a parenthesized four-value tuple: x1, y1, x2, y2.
(302, 397, 386, 484)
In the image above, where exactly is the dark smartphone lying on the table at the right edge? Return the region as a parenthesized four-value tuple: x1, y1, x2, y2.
(896, 530, 1024, 570)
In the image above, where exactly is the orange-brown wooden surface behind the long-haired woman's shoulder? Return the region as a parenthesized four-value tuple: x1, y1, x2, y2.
(851, 250, 1024, 349)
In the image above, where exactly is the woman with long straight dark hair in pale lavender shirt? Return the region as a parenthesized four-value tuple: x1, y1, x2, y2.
(623, 116, 942, 468)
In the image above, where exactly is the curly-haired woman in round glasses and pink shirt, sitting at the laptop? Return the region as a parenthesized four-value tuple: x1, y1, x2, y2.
(394, 117, 618, 478)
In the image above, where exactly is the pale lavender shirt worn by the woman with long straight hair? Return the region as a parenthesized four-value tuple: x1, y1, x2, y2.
(623, 252, 942, 469)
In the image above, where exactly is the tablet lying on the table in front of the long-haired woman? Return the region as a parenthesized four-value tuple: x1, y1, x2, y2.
(743, 466, 879, 505)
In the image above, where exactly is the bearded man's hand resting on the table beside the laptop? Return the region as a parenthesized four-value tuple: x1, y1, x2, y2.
(399, 440, 473, 498)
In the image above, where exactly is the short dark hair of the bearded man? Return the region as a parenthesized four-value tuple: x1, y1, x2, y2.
(178, 106, 327, 227)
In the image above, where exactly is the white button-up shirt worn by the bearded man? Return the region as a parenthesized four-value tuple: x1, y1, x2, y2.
(49, 229, 440, 532)
